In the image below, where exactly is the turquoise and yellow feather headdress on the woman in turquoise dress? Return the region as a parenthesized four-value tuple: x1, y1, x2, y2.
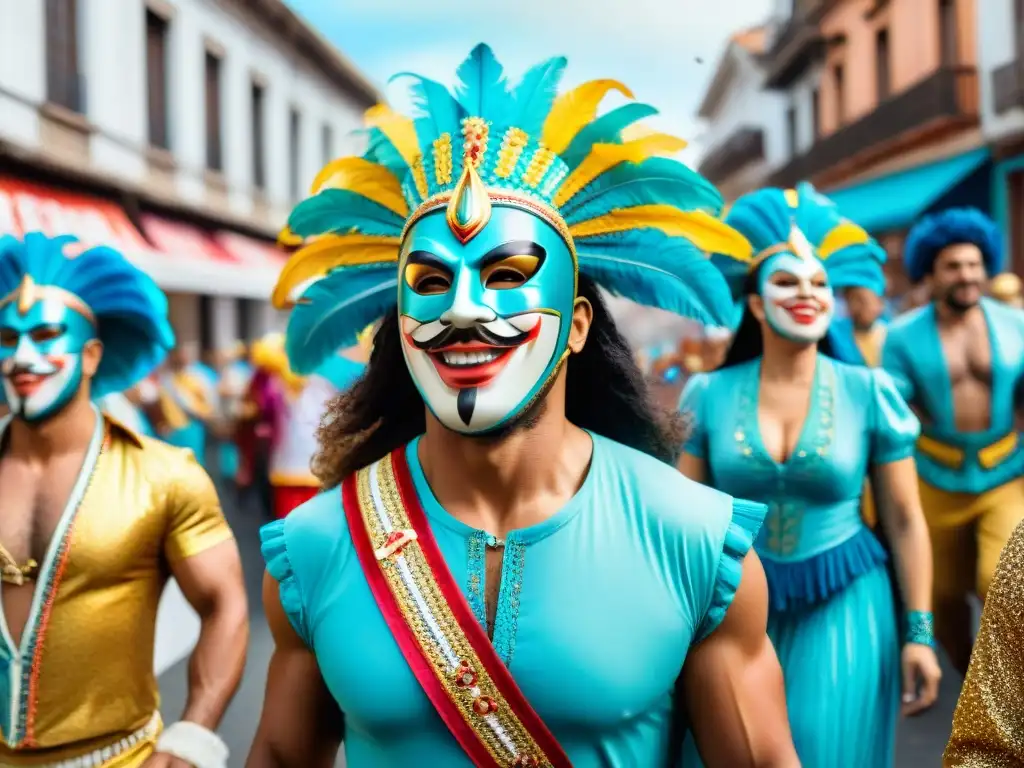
(712, 182, 886, 300)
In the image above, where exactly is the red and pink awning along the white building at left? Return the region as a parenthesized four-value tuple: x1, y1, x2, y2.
(0, 176, 283, 299)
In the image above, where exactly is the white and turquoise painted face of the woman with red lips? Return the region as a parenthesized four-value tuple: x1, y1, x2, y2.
(760, 253, 836, 344)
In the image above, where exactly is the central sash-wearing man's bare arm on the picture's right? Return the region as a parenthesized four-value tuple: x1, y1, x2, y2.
(683, 552, 800, 768)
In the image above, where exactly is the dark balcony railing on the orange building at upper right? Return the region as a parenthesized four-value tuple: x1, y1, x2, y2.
(771, 67, 978, 185)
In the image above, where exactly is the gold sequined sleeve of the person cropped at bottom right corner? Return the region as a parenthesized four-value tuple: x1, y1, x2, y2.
(942, 523, 1024, 768)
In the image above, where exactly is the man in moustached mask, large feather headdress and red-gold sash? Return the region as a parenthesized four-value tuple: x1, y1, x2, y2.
(249, 46, 796, 768)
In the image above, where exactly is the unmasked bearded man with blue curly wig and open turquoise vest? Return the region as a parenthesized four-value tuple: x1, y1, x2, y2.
(883, 209, 1024, 673)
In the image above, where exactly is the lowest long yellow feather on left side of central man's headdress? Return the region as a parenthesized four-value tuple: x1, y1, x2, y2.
(270, 234, 401, 309)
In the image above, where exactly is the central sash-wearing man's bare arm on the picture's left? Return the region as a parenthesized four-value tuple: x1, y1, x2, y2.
(246, 573, 344, 768)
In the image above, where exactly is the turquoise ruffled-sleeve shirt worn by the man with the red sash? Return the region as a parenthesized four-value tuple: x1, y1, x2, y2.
(261, 434, 766, 768)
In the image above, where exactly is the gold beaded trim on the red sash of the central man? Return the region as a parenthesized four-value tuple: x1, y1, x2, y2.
(355, 456, 551, 767)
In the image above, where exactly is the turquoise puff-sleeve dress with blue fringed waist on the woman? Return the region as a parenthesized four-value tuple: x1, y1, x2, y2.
(681, 355, 920, 768)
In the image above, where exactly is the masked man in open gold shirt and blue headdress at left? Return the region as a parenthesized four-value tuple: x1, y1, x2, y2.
(0, 234, 248, 768)
